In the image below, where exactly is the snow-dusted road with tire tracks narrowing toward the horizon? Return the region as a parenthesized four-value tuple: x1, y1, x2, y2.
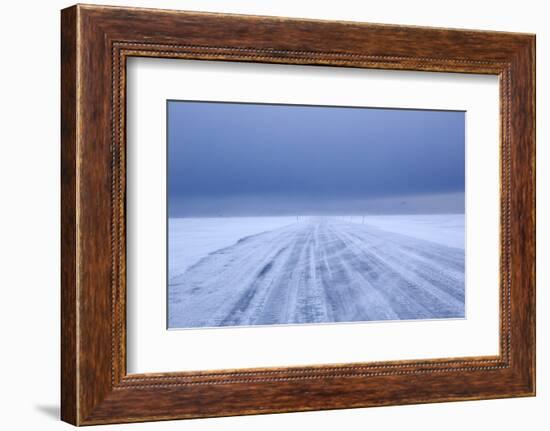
(169, 218, 464, 328)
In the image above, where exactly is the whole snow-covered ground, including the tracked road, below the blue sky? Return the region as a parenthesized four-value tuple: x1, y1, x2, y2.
(168, 214, 465, 328)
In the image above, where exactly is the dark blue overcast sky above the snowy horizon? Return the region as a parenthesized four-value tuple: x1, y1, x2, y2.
(168, 101, 465, 217)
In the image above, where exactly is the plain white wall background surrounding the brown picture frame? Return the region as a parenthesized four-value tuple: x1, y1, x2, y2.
(0, 0, 550, 431)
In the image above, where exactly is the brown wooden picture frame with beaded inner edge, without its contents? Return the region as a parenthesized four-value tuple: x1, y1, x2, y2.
(61, 5, 535, 425)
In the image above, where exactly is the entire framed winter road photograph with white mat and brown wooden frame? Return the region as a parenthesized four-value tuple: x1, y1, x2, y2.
(61, 5, 535, 425)
